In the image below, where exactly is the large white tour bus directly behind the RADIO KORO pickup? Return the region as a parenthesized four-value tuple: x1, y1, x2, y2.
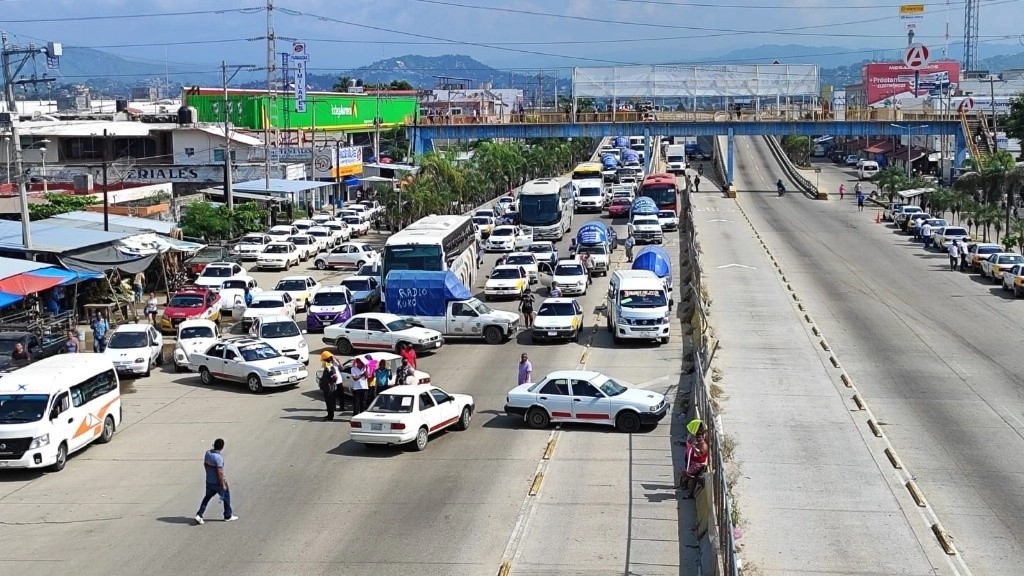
(381, 215, 476, 300)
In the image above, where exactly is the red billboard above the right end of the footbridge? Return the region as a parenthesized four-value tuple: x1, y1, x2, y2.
(864, 60, 959, 107)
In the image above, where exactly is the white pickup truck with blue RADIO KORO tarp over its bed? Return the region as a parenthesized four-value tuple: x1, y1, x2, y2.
(385, 270, 519, 344)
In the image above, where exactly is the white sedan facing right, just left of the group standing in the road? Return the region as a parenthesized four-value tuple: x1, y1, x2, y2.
(188, 338, 309, 394)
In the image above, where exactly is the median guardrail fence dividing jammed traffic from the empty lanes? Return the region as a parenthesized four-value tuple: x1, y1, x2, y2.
(682, 183, 739, 576)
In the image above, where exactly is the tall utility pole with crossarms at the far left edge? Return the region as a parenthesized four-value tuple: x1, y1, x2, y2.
(0, 32, 63, 250)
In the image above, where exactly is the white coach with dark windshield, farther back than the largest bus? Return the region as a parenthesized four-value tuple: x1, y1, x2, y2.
(518, 175, 573, 240)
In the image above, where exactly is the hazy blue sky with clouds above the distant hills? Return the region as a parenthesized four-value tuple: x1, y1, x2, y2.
(0, 0, 1024, 74)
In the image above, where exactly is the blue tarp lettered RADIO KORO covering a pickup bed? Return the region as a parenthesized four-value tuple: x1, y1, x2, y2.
(384, 270, 473, 316)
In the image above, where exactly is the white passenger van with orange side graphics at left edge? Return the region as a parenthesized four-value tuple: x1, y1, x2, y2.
(0, 354, 121, 471)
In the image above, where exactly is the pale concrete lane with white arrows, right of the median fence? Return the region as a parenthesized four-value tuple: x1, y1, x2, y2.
(693, 191, 934, 576)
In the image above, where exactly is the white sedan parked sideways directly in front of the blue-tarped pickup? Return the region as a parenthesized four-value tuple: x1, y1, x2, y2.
(323, 312, 444, 356)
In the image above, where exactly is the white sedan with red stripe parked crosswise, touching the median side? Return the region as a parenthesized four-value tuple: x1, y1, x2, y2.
(505, 370, 669, 434)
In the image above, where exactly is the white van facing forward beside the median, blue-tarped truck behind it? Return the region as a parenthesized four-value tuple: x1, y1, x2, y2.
(606, 270, 672, 344)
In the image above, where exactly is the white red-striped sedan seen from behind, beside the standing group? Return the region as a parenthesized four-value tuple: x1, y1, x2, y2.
(349, 384, 474, 451)
